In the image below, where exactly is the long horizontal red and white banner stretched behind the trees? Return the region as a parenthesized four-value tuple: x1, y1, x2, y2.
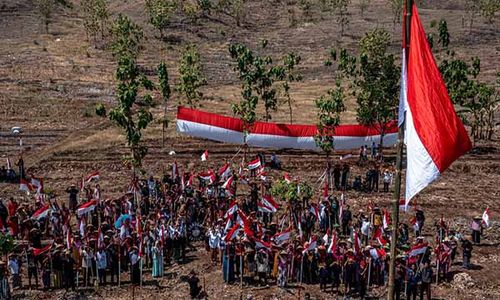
(177, 107, 398, 150)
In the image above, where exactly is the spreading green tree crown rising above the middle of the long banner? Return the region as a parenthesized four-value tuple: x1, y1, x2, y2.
(229, 41, 288, 126)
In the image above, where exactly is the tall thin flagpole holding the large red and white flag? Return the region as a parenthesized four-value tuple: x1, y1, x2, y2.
(387, 0, 413, 300)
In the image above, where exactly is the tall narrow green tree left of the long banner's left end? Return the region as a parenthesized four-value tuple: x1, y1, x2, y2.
(96, 15, 154, 171)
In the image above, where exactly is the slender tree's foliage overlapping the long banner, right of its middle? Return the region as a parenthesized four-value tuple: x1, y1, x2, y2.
(314, 81, 346, 156)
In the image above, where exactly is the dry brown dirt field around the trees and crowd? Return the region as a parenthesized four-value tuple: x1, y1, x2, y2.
(0, 0, 500, 299)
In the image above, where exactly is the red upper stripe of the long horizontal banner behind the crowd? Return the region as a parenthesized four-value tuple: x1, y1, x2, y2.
(177, 107, 398, 137)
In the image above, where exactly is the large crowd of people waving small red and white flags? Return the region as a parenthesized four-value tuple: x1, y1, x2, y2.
(0, 152, 484, 299)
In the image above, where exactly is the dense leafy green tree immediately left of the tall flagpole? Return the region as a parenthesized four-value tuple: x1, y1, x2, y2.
(338, 29, 400, 148)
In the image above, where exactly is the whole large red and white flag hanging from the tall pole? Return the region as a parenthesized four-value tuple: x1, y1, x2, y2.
(400, 5, 472, 203)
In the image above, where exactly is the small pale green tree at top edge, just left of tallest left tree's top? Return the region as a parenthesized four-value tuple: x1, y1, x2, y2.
(80, 0, 109, 43)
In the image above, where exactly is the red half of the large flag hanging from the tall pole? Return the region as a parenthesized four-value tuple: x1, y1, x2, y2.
(408, 5, 472, 173)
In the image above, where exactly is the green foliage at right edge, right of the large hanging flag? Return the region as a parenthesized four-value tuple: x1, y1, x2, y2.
(439, 53, 500, 141)
